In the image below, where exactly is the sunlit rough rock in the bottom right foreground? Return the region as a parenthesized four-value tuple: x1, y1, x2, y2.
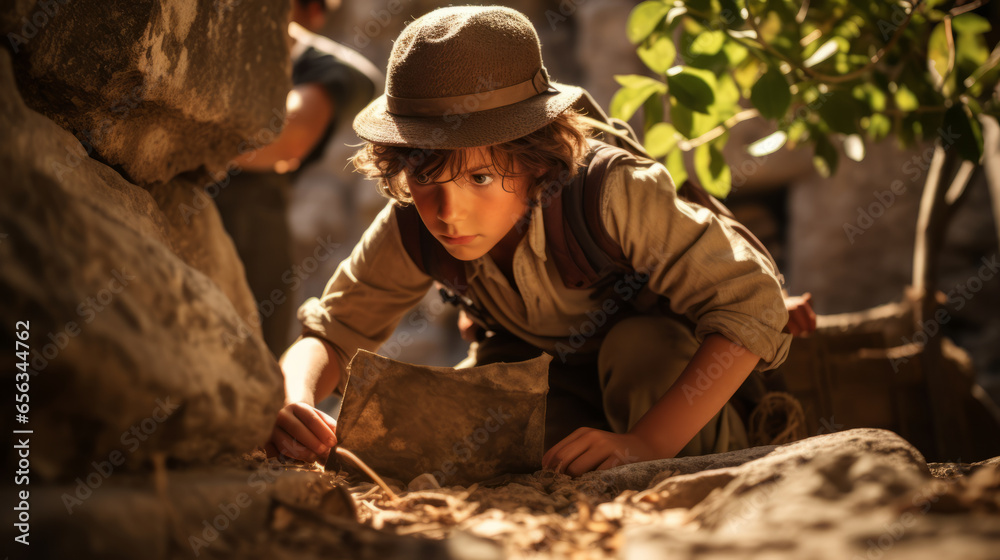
(622, 430, 998, 559)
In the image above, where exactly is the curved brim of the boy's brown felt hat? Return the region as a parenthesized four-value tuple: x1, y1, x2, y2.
(354, 82, 583, 150)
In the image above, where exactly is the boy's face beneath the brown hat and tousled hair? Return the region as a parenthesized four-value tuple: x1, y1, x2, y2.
(406, 148, 532, 261)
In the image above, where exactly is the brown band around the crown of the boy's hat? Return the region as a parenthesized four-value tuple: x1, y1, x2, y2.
(385, 68, 558, 117)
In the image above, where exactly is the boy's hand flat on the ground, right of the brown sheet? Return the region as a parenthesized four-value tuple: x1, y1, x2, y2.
(542, 428, 662, 476)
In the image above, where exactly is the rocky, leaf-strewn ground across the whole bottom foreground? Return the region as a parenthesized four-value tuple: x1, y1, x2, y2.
(9, 430, 1000, 560)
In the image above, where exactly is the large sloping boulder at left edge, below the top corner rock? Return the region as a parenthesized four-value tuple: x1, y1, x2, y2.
(0, 52, 282, 483)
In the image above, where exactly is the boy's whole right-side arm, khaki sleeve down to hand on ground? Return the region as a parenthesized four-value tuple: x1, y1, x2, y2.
(543, 165, 791, 475)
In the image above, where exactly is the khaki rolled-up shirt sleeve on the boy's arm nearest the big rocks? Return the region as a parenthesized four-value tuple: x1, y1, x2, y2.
(298, 203, 432, 393)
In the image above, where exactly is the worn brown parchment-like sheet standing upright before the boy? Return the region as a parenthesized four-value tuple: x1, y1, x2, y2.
(337, 350, 552, 485)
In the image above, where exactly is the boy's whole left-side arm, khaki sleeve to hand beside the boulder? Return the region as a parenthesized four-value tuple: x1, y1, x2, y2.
(265, 204, 432, 461)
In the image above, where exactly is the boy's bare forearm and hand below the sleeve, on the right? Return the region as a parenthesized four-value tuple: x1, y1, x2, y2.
(542, 334, 760, 476)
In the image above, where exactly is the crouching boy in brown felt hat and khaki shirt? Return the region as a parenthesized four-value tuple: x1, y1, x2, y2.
(271, 7, 791, 476)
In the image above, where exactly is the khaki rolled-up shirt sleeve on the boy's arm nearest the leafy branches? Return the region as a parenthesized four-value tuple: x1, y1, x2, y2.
(602, 164, 791, 371)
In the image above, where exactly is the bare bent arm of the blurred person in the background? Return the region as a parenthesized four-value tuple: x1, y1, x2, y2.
(233, 83, 334, 172)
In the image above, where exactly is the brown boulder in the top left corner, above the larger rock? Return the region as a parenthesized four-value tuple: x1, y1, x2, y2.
(0, 0, 291, 184)
